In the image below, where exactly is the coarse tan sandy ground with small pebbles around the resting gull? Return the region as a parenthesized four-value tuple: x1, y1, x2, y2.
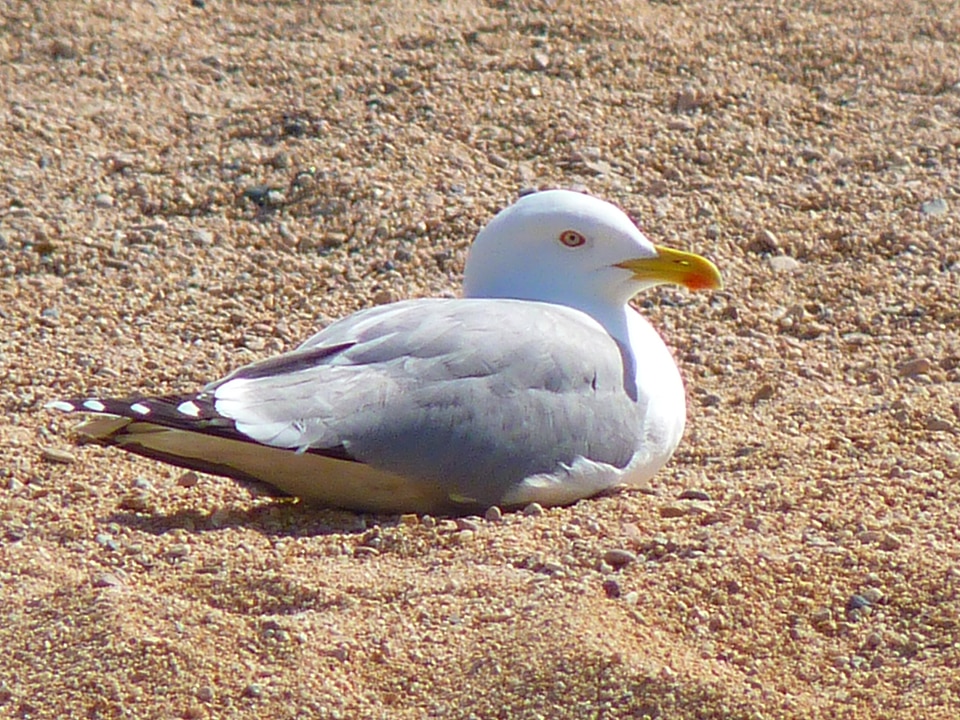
(0, 0, 960, 719)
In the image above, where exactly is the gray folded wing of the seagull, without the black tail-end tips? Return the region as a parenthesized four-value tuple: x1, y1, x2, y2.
(210, 299, 642, 502)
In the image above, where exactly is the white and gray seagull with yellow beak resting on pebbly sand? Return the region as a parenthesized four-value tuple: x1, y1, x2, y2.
(47, 190, 722, 514)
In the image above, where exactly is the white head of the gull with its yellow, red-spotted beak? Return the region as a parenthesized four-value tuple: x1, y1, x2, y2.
(464, 190, 722, 314)
